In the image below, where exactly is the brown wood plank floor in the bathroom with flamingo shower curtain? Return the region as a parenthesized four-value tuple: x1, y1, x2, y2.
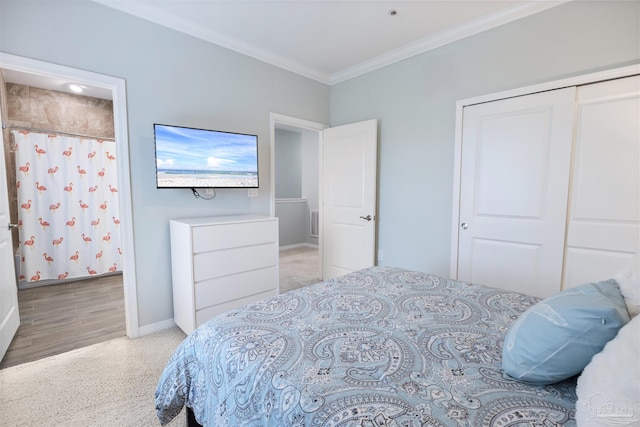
(0, 274, 126, 369)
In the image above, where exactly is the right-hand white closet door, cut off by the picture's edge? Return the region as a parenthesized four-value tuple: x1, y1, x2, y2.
(564, 76, 640, 288)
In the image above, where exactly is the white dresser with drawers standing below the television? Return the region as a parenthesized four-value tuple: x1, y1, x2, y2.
(169, 215, 278, 334)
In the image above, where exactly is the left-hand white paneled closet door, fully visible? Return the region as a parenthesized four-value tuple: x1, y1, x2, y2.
(457, 88, 575, 297)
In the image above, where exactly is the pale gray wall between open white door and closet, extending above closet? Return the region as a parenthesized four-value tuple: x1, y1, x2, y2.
(330, 1, 640, 276)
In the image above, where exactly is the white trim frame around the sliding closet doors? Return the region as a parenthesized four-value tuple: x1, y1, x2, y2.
(449, 64, 640, 279)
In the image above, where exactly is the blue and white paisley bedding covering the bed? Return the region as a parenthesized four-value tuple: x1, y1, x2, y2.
(156, 267, 576, 427)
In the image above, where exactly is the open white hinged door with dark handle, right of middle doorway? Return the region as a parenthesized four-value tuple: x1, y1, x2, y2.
(320, 120, 378, 280)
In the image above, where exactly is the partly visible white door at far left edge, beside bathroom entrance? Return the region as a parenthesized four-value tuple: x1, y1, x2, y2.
(0, 132, 20, 360)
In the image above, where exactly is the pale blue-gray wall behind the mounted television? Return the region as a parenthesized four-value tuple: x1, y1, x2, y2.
(0, 0, 329, 326)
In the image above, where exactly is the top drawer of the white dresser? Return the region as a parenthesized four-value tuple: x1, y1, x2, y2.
(192, 221, 278, 254)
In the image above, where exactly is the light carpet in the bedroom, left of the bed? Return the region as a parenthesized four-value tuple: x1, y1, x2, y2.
(0, 327, 186, 427)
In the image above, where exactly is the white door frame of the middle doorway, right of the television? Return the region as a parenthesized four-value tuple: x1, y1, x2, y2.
(269, 113, 329, 279)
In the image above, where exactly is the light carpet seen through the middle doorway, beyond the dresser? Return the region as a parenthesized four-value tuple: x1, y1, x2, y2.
(279, 246, 320, 292)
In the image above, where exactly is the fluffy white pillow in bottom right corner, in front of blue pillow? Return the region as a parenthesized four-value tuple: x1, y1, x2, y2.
(576, 316, 640, 427)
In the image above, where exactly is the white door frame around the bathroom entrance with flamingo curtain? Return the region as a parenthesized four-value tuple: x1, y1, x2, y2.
(0, 52, 140, 338)
